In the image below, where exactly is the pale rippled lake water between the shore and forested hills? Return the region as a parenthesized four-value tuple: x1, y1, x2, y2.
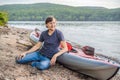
(8, 21, 120, 60)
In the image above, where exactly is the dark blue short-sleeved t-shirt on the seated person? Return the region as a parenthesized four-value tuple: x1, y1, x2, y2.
(39, 29, 65, 58)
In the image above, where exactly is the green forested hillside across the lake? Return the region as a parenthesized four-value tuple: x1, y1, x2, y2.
(0, 3, 120, 21)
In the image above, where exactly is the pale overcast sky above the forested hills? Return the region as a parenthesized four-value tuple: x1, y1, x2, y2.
(0, 0, 120, 9)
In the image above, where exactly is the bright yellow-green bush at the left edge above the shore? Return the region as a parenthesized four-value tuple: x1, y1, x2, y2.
(0, 11, 8, 26)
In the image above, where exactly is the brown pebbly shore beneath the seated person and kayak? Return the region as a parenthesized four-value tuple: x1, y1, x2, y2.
(0, 28, 120, 80)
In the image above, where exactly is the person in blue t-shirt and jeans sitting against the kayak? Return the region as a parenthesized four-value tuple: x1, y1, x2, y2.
(16, 16, 68, 70)
